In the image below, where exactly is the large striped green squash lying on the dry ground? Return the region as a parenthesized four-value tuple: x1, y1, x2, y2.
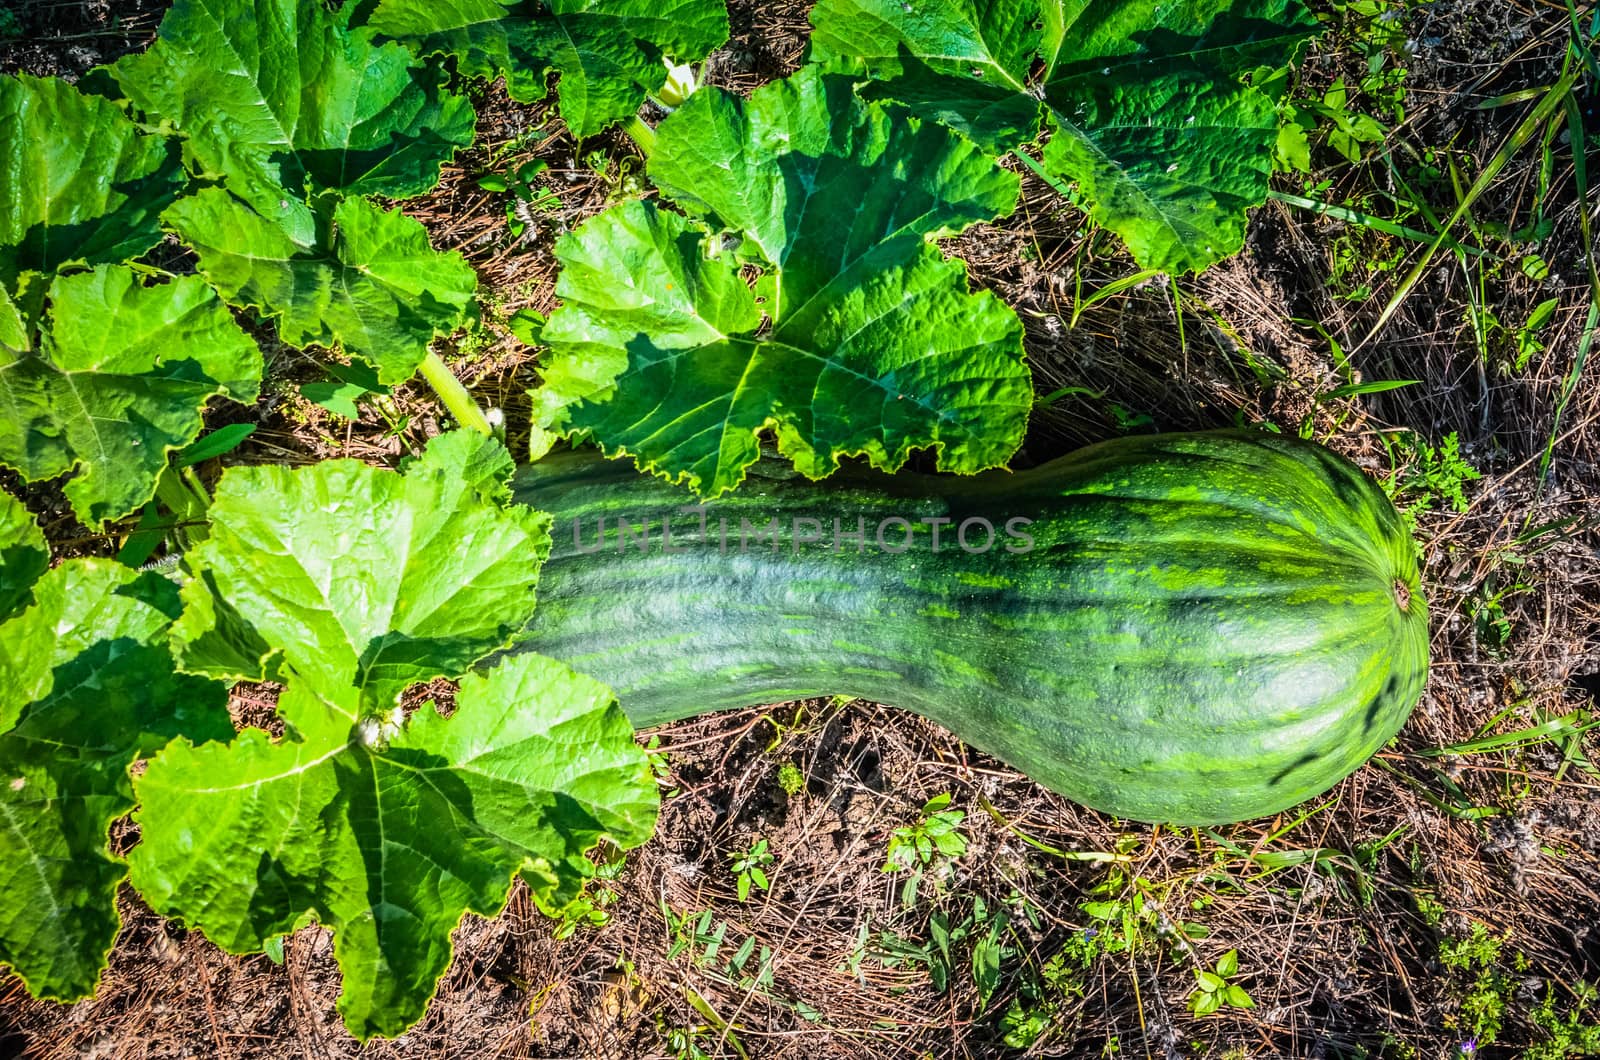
(514, 431, 1429, 825)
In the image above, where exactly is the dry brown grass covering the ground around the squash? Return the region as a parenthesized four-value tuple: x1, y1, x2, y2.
(0, 0, 1600, 1060)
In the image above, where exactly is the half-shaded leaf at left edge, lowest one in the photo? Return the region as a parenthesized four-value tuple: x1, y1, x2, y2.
(0, 559, 234, 1001)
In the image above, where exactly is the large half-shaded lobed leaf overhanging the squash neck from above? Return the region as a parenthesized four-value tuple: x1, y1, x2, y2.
(533, 69, 1030, 496)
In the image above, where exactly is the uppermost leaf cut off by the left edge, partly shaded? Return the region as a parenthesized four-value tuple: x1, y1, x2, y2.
(0, 74, 181, 288)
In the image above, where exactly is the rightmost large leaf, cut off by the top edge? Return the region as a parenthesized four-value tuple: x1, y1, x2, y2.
(811, 0, 1317, 272)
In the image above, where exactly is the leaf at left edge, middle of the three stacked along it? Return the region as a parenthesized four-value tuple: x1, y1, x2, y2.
(0, 266, 261, 527)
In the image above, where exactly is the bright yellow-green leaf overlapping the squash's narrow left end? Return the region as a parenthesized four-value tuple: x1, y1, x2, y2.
(131, 432, 656, 1038)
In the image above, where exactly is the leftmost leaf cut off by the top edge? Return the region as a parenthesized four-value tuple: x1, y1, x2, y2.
(112, 0, 474, 243)
